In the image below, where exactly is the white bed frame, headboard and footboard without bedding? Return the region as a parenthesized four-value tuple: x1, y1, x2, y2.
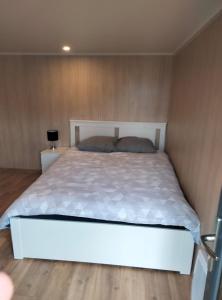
(10, 120, 194, 274)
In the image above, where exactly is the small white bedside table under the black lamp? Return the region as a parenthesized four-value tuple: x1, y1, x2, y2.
(41, 147, 69, 173)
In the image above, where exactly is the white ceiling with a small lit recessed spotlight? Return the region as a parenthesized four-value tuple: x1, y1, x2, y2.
(0, 0, 222, 54)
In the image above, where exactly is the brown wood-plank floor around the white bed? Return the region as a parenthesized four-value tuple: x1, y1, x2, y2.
(0, 169, 190, 300)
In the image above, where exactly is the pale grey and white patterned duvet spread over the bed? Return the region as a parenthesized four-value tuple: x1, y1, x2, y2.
(0, 149, 200, 242)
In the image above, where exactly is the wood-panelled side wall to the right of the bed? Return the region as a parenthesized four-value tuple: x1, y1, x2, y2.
(167, 16, 222, 233)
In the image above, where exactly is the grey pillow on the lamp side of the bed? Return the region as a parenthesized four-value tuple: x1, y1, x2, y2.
(77, 136, 117, 152)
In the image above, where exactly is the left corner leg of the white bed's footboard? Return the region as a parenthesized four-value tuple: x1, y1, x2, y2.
(10, 217, 24, 259)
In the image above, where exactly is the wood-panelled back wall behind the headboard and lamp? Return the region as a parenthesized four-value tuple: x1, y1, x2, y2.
(0, 56, 172, 169)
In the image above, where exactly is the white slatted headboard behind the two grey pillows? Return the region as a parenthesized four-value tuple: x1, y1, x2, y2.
(70, 120, 166, 151)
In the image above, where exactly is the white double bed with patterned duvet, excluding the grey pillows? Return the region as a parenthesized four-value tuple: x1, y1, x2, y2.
(0, 120, 199, 274)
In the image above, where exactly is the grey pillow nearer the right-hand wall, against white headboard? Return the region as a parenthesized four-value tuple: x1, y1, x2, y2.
(115, 136, 156, 153)
